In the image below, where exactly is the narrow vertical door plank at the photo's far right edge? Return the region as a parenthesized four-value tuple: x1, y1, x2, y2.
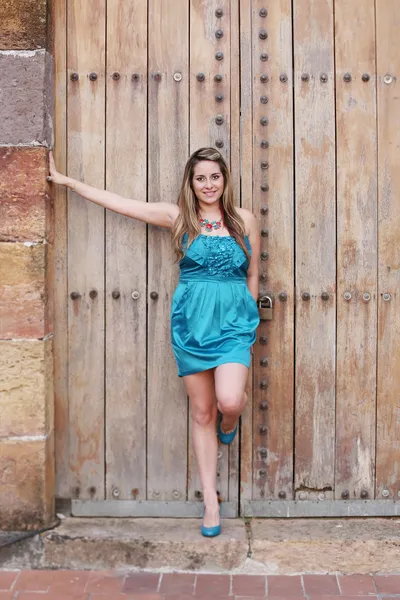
(376, 0, 400, 499)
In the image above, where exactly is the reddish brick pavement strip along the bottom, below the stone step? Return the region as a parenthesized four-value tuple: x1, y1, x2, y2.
(0, 571, 400, 600)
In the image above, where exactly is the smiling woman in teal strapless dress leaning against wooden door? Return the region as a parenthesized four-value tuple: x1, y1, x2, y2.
(48, 148, 260, 537)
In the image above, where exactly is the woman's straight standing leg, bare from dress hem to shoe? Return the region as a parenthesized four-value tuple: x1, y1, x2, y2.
(183, 370, 219, 527)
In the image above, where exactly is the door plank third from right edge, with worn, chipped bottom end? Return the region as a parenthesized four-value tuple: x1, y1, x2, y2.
(293, 0, 336, 499)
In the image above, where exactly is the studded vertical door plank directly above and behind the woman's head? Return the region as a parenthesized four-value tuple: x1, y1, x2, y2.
(188, 0, 233, 500)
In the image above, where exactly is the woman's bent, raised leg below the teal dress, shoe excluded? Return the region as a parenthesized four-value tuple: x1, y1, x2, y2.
(214, 363, 249, 433)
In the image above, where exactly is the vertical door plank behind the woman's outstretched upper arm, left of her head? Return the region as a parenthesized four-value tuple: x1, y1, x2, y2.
(147, 0, 189, 500)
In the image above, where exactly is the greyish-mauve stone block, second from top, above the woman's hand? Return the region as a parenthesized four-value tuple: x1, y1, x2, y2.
(0, 50, 53, 146)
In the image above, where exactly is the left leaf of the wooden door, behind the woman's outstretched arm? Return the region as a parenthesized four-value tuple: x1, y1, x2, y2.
(56, 0, 240, 516)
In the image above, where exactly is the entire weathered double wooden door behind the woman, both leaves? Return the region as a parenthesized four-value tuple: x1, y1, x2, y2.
(55, 0, 400, 517)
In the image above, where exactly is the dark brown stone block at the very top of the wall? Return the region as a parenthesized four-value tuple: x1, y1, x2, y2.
(0, 0, 47, 50)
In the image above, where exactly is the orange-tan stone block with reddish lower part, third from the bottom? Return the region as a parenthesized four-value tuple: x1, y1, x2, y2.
(0, 242, 53, 339)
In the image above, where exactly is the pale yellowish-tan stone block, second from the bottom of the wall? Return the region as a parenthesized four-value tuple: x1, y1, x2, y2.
(0, 338, 54, 438)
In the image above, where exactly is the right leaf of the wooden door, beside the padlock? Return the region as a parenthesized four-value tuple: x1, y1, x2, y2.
(241, 0, 400, 517)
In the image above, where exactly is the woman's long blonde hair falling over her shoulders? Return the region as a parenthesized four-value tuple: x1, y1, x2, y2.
(172, 148, 249, 260)
